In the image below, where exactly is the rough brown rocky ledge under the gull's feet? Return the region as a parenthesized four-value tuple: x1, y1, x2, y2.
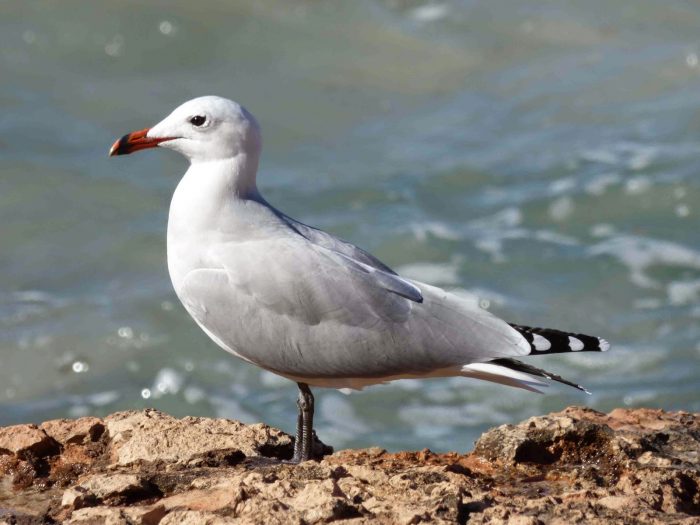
(0, 407, 700, 525)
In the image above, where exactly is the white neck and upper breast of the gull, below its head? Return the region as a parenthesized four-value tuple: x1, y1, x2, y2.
(168, 154, 265, 290)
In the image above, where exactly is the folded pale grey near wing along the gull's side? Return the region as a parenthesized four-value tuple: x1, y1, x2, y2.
(178, 237, 529, 378)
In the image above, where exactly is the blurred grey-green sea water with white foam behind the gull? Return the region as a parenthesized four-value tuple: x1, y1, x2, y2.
(0, 0, 700, 451)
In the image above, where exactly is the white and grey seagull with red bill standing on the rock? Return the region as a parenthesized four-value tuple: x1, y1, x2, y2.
(109, 96, 610, 463)
